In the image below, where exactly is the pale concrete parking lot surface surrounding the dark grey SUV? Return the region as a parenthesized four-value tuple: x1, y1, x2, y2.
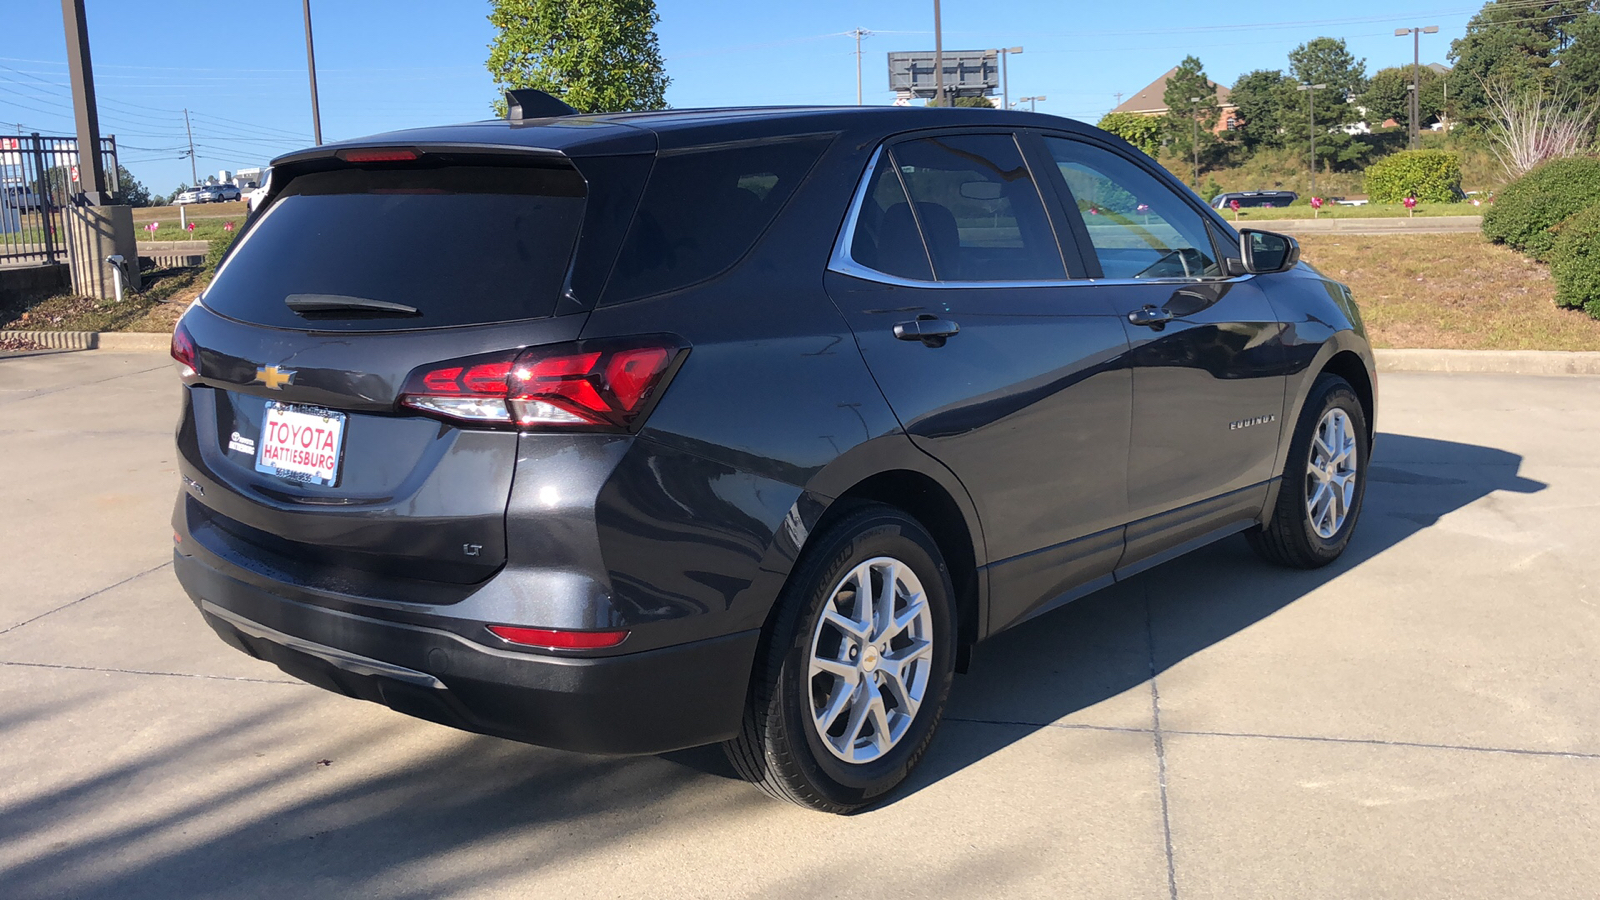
(0, 351, 1600, 900)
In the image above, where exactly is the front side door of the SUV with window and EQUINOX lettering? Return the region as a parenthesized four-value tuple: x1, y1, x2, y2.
(1043, 136, 1285, 564)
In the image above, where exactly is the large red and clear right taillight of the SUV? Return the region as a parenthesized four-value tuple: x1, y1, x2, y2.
(400, 335, 688, 431)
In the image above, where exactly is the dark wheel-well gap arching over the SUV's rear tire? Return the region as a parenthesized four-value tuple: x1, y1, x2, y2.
(818, 469, 978, 671)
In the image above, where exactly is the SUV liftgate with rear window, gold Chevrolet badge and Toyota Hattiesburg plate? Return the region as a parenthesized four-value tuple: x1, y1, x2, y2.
(179, 152, 624, 589)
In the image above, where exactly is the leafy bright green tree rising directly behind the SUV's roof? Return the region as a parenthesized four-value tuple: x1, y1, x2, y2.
(485, 0, 670, 112)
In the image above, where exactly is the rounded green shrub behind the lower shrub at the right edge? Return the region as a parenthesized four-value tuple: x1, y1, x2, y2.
(1483, 157, 1600, 259)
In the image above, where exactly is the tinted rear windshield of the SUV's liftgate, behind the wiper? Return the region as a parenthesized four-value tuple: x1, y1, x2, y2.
(203, 167, 584, 331)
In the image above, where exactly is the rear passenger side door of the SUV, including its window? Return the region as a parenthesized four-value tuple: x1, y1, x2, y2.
(826, 131, 1131, 629)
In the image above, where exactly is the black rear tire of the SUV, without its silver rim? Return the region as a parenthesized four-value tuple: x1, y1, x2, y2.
(723, 503, 957, 814)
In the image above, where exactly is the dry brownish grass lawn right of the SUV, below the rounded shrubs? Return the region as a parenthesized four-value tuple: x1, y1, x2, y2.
(1299, 234, 1600, 351)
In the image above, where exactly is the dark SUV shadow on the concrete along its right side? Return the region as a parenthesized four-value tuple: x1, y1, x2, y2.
(890, 434, 1547, 802)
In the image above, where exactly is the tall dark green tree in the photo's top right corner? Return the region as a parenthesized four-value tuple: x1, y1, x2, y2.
(1450, 0, 1594, 125)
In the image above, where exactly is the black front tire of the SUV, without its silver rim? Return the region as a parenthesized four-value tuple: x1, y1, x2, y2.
(1245, 373, 1371, 569)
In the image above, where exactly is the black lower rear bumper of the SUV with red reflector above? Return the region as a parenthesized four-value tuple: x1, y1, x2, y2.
(174, 552, 760, 754)
